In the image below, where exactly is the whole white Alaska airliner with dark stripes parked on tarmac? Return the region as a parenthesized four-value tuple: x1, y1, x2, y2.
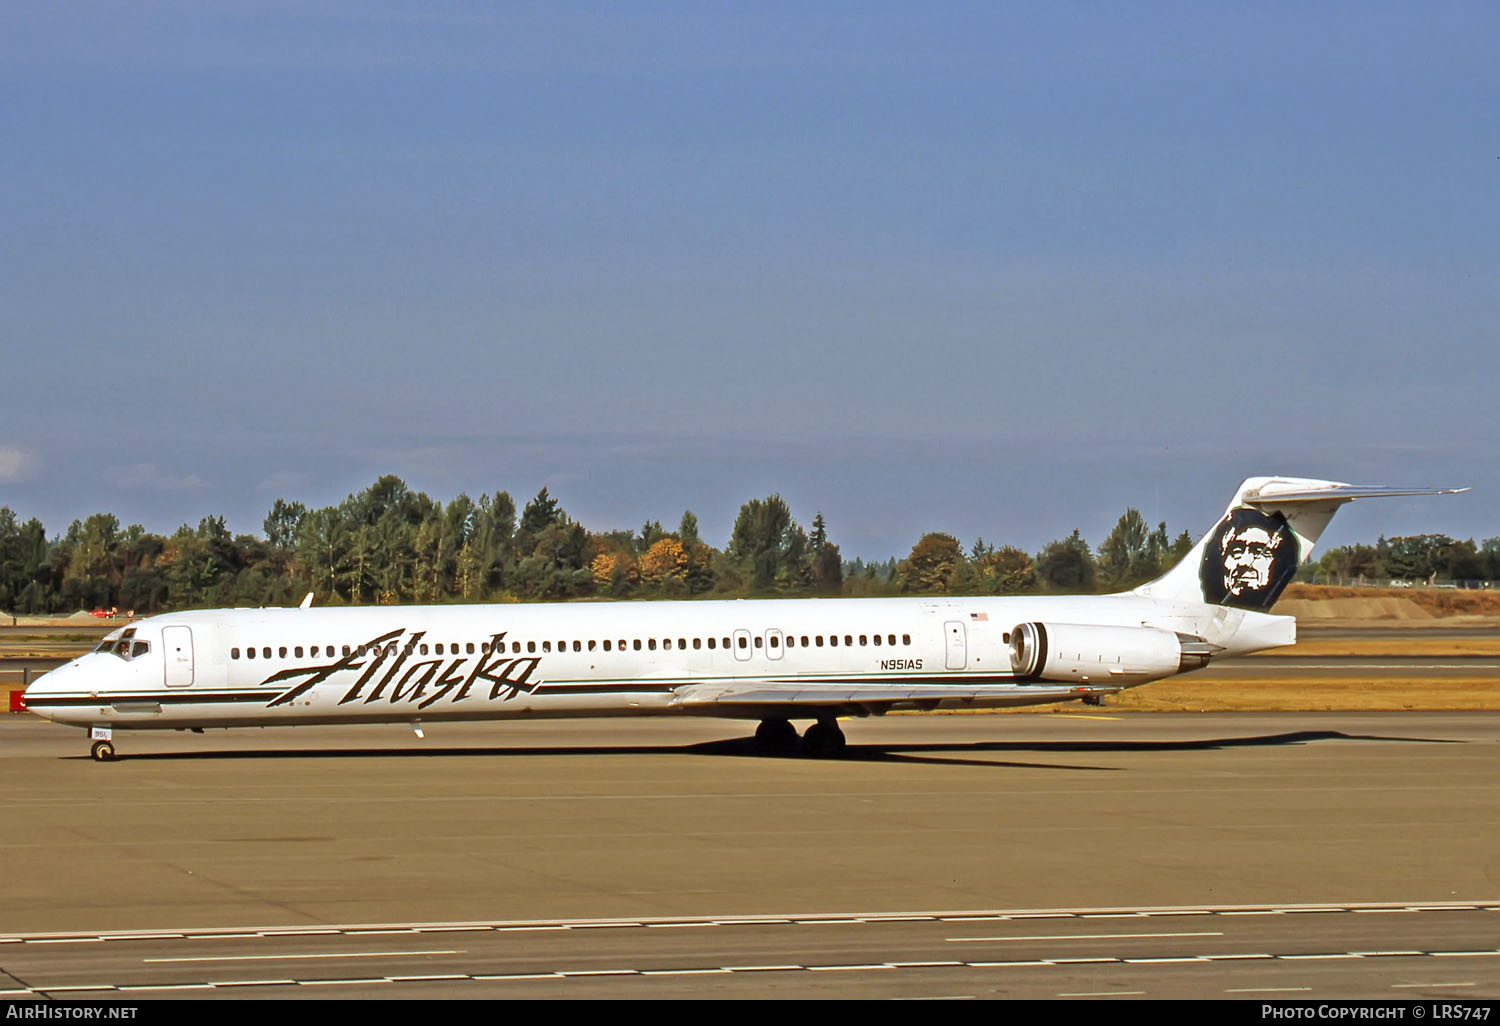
(17, 477, 1466, 762)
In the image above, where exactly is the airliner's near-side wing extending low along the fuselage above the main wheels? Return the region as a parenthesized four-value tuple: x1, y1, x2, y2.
(672, 680, 1124, 716)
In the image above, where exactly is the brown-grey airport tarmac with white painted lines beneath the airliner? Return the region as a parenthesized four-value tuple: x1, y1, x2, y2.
(0, 710, 1500, 999)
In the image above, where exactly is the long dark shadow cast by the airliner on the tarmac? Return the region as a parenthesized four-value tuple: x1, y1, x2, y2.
(77, 731, 1461, 771)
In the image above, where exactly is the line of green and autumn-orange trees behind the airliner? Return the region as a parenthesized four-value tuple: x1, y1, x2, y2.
(0, 476, 1500, 615)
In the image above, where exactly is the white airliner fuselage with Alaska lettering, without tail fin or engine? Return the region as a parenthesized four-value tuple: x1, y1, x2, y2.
(27, 596, 1293, 729)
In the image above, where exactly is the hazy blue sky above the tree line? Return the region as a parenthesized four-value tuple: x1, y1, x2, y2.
(0, 0, 1500, 558)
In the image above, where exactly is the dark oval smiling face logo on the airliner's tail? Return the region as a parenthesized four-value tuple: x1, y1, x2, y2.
(1199, 507, 1299, 611)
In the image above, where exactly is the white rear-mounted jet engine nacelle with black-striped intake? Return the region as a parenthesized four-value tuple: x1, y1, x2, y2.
(1011, 624, 1215, 684)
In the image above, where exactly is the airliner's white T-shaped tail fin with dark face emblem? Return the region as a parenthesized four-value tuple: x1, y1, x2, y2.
(1134, 477, 1469, 612)
